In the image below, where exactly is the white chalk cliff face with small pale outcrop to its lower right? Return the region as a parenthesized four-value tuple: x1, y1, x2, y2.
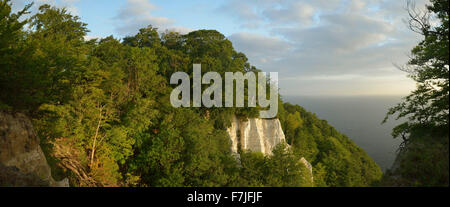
(227, 116, 313, 180)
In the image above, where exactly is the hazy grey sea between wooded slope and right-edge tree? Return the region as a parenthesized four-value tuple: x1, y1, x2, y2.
(282, 96, 408, 171)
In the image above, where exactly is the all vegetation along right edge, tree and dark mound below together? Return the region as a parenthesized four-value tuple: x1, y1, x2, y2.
(383, 0, 449, 186)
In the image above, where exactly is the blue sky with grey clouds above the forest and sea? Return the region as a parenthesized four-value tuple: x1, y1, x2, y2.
(8, 0, 427, 96)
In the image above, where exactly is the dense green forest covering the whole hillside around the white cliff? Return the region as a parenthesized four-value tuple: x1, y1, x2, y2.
(0, 0, 381, 186)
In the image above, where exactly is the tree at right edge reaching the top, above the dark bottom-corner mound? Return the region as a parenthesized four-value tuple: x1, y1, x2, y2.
(384, 0, 449, 143)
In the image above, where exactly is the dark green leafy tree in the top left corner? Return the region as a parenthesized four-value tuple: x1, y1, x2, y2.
(0, 1, 87, 113)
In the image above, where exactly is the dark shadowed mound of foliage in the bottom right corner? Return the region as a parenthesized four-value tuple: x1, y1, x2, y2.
(380, 127, 449, 187)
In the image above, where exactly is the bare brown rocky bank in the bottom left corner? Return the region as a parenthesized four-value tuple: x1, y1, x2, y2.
(0, 111, 69, 187)
